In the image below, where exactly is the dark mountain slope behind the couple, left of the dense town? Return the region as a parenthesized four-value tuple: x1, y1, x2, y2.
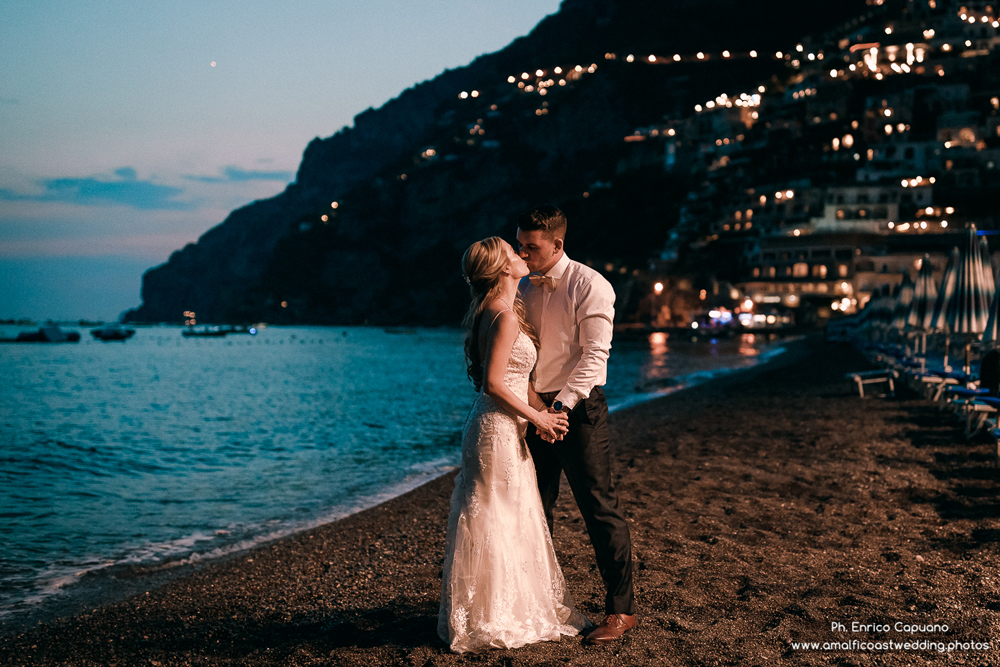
(126, 0, 868, 325)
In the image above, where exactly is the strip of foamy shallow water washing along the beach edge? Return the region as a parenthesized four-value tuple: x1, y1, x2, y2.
(0, 331, 788, 637)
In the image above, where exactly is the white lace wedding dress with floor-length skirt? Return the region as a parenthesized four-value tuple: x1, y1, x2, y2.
(438, 333, 587, 653)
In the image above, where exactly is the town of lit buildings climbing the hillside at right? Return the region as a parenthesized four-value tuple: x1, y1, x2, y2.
(625, 0, 1000, 326)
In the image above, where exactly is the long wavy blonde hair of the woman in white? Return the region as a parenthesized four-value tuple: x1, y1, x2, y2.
(462, 236, 538, 391)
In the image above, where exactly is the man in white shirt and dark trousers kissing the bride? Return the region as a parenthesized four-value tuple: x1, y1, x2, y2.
(517, 206, 636, 644)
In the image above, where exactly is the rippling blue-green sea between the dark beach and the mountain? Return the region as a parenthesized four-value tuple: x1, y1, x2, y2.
(0, 326, 785, 627)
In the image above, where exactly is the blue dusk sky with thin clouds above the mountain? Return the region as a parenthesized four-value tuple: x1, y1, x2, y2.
(0, 0, 559, 320)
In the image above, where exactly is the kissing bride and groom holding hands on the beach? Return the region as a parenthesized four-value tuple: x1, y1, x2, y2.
(438, 206, 636, 653)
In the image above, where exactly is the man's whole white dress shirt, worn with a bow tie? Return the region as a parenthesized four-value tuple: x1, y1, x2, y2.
(520, 254, 615, 409)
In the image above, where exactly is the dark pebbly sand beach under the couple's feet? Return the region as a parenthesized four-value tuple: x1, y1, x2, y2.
(0, 338, 1000, 667)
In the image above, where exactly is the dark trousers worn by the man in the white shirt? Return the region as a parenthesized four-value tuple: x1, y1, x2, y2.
(527, 387, 635, 614)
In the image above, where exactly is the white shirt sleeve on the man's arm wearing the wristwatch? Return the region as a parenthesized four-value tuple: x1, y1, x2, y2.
(556, 278, 615, 409)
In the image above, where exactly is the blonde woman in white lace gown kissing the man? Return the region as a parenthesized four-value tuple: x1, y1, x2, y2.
(438, 236, 588, 653)
